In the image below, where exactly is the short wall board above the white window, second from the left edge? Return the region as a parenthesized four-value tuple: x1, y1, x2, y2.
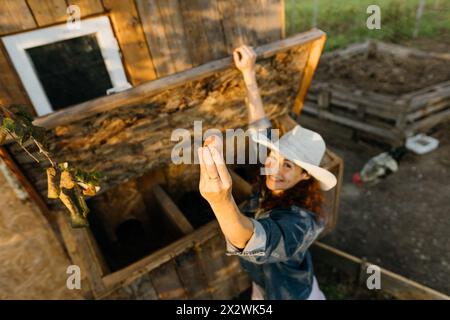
(28, 0, 68, 27)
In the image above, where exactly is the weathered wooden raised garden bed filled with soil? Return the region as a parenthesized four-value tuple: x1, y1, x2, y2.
(303, 41, 450, 145)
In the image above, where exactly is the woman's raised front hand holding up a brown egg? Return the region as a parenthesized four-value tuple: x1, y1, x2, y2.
(197, 135, 232, 205)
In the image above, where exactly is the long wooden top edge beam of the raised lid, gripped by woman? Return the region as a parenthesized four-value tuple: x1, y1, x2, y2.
(34, 30, 325, 129)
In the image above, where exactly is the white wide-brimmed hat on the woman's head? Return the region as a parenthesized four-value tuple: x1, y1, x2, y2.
(251, 125, 337, 191)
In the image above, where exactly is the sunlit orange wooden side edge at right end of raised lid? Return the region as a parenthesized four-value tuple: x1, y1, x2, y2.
(294, 34, 326, 116)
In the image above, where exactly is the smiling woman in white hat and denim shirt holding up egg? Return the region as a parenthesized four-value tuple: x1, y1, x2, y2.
(198, 46, 336, 299)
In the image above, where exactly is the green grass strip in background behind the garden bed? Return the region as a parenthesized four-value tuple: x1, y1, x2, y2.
(285, 0, 450, 51)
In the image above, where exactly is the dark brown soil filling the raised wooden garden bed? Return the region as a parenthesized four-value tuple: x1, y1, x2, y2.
(314, 48, 450, 95)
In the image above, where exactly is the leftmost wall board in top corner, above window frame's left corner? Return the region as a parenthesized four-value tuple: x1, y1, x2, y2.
(0, 0, 36, 35)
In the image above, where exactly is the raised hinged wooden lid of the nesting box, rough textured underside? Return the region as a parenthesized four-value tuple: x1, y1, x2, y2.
(4, 29, 326, 198)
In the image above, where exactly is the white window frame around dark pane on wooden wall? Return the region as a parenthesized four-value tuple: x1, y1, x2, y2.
(2, 16, 131, 116)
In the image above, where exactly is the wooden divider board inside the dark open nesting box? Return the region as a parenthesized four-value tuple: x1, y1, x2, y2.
(153, 185, 194, 234)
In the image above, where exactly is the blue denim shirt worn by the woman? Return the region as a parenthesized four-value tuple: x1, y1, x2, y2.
(227, 117, 325, 300)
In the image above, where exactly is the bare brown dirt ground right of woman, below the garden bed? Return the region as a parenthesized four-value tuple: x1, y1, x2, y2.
(300, 116, 450, 294)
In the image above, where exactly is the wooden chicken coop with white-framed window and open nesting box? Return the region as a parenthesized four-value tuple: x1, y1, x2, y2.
(0, 0, 343, 299)
